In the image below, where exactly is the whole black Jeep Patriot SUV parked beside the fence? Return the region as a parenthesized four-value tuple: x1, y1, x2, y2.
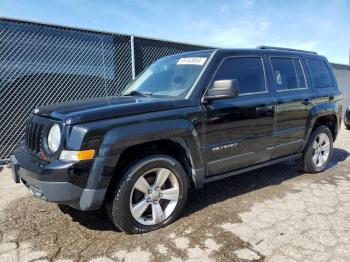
(11, 47, 342, 233)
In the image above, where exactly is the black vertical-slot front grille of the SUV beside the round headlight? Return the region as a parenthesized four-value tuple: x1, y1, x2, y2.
(26, 117, 44, 153)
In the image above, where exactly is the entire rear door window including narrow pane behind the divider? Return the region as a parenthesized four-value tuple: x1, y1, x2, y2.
(271, 57, 306, 90)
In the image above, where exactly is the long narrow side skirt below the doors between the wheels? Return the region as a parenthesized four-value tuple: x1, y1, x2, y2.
(204, 153, 303, 184)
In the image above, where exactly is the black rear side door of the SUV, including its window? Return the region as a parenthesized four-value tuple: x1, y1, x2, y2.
(269, 56, 316, 158)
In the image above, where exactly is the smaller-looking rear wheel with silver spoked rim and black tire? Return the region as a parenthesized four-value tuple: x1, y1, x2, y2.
(303, 126, 333, 173)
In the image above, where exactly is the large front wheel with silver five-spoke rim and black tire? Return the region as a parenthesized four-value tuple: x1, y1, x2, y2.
(106, 155, 189, 233)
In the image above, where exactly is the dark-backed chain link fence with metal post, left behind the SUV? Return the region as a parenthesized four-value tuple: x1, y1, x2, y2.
(0, 18, 211, 161)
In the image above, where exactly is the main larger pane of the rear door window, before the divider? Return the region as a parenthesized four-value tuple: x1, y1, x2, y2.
(271, 58, 299, 90)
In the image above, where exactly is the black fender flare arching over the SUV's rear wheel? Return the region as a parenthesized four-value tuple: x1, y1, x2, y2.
(304, 102, 340, 144)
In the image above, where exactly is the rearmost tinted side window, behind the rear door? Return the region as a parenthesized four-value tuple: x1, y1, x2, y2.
(307, 59, 333, 87)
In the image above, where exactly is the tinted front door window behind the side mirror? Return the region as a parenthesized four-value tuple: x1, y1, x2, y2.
(214, 57, 265, 94)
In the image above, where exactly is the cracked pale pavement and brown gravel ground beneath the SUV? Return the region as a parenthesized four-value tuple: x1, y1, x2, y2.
(0, 126, 350, 262)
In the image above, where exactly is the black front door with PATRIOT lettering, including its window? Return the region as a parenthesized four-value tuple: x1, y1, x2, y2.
(204, 56, 274, 176)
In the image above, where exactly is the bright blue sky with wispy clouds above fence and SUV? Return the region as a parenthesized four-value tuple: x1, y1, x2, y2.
(0, 0, 350, 64)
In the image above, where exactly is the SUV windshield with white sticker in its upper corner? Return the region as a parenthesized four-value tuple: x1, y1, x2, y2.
(122, 51, 211, 97)
